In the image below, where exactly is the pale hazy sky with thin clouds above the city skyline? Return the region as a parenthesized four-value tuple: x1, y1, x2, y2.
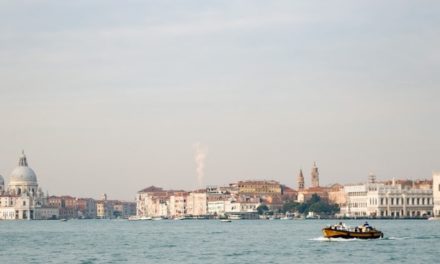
(0, 0, 440, 200)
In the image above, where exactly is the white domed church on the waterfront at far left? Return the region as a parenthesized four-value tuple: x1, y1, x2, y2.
(0, 151, 59, 220)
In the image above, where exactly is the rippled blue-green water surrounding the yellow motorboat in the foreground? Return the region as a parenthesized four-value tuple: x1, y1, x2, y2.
(0, 220, 440, 264)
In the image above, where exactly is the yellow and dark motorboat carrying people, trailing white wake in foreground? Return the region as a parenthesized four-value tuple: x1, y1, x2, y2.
(322, 222, 383, 239)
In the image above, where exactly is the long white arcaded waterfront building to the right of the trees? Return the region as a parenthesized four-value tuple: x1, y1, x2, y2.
(341, 176, 434, 218)
